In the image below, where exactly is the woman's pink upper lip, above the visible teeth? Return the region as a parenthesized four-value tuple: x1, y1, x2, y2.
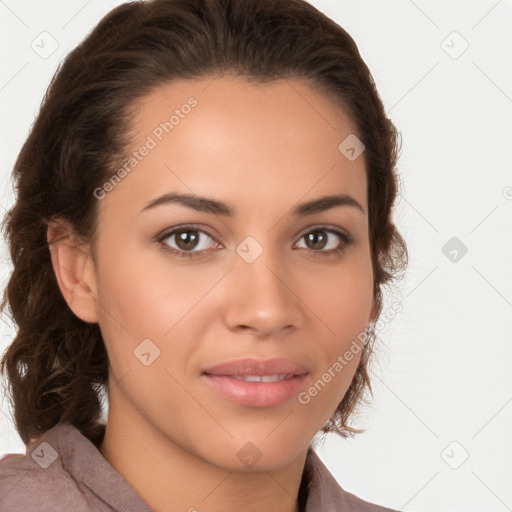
(202, 357, 308, 376)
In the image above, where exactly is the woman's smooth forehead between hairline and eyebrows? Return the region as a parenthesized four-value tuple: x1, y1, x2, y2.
(105, 76, 366, 218)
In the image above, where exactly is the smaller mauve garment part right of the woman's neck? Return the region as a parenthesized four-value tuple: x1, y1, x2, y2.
(306, 449, 397, 512)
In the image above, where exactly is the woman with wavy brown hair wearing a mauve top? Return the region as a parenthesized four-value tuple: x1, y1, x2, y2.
(0, 0, 406, 512)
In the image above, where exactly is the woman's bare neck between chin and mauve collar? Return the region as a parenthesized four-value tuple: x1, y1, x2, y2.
(99, 411, 307, 512)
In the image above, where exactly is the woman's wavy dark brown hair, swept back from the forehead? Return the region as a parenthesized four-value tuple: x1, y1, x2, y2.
(1, 0, 407, 444)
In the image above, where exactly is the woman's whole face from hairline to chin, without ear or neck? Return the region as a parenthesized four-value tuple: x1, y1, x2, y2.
(94, 77, 373, 470)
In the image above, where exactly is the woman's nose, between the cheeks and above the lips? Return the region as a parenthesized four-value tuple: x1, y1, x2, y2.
(225, 242, 302, 338)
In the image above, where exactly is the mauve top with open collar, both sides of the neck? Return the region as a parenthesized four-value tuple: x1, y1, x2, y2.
(0, 423, 396, 512)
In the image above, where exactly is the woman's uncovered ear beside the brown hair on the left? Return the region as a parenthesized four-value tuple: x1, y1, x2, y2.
(46, 219, 98, 323)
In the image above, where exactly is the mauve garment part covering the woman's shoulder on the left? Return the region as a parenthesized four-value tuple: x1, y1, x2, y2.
(0, 422, 151, 512)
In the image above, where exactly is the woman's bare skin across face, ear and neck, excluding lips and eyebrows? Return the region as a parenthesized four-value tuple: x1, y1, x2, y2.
(48, 76, 373, 512)
